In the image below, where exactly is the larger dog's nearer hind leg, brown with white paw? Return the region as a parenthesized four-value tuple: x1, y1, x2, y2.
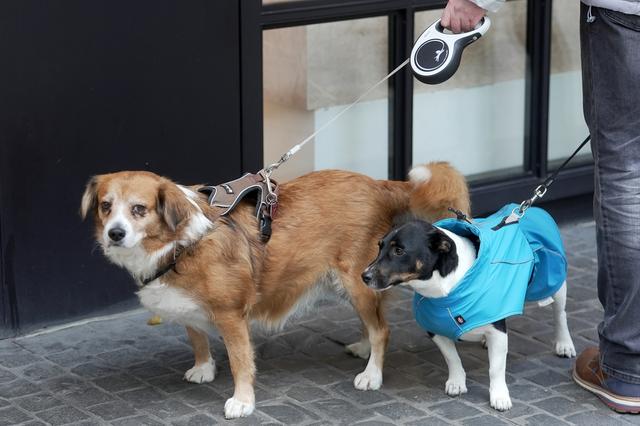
(343, 274, 389, 390)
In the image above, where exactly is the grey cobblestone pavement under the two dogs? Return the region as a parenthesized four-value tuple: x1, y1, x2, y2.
(0, 218, 640, 426)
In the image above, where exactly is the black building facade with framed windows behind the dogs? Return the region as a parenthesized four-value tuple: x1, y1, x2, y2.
(0, 0, 592, 338)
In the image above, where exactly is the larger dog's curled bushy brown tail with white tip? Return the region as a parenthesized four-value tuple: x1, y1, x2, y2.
(409, 161, 471, 222)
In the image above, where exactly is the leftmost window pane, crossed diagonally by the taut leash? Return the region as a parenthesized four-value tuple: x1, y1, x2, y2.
(263, 17, 389, 180)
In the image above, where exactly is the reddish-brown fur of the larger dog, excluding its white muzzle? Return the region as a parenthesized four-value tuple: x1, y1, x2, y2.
(81, 163, 469, 416)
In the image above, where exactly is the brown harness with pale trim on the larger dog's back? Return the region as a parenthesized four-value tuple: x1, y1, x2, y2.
(198, 170, 278, 243)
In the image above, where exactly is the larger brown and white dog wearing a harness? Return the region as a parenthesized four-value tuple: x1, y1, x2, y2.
(81, 163, 469, 418)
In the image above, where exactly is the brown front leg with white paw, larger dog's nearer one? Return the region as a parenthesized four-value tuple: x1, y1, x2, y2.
(216, 313, 256, 419)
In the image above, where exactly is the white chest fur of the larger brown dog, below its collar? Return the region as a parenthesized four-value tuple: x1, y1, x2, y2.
(137, 279, 211, 331)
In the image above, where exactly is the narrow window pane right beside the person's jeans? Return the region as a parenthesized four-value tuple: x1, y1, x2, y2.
(548, 1, 591, 165)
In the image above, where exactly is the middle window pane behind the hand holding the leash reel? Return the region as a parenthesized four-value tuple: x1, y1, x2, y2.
(413, 0, 526, 180)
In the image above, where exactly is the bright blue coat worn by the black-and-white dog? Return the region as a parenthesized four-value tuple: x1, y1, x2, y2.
(413, 204, 567, 340)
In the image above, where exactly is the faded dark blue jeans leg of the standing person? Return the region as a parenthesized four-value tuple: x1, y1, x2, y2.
(580, 5, 640, 384)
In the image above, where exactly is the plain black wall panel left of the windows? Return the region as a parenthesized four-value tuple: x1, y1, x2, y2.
(0, 0, 242, 337)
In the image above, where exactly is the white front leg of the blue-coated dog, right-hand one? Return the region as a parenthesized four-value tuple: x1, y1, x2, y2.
(485, 327, 512, 411)
